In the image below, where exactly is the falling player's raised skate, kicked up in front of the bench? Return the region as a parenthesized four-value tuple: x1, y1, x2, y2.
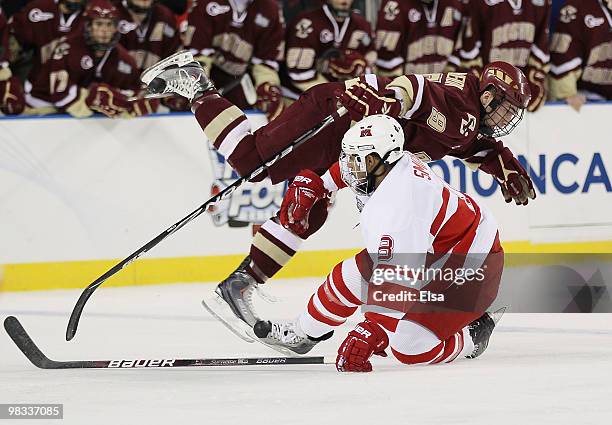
(140, 50, 215, 101)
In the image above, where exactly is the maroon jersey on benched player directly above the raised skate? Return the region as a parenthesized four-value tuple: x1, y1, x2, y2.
(116, 1, 181, 70)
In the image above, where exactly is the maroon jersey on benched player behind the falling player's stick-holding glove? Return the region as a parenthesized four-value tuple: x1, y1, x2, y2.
(285, 5, 376, 91)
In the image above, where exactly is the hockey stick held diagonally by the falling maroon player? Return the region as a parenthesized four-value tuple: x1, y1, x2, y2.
(66, 107, 348, 341)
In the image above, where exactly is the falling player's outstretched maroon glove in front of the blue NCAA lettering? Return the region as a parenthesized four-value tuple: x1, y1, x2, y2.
(480, 141, 536, 205)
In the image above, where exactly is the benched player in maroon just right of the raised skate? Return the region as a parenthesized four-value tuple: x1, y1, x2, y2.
(184, 0, 285, 120)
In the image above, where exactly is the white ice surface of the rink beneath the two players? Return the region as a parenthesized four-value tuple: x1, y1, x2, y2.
(0, 279, 612, 425)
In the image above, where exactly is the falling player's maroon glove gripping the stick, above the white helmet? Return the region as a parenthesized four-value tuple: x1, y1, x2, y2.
(334, 82, 402, 121)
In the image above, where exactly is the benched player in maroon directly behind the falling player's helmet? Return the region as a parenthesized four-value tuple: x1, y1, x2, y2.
(450, 0, 551, 112)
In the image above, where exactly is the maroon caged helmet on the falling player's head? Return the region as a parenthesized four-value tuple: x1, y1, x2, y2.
(480, 61, 531, 137)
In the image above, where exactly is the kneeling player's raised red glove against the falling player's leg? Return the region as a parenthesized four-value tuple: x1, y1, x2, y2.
(279, 170, 328, 235)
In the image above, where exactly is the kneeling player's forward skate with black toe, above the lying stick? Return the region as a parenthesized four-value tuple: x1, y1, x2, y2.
(253, 320, 333, 355)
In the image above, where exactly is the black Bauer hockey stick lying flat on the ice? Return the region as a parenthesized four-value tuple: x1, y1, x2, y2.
(4, 316, 331, 369)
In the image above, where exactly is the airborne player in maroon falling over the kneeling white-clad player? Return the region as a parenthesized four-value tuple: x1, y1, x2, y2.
(141, 52, 535, 325)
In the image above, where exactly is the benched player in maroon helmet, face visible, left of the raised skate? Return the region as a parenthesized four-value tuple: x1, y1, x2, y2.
(26, 0, 154, 117)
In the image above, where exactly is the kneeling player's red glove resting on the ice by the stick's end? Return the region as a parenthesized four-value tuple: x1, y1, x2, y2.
(336, 320, 389, 372)
